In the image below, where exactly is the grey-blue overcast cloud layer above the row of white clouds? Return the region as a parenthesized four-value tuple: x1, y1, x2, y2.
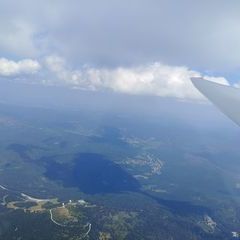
(0, 0, 240, 74)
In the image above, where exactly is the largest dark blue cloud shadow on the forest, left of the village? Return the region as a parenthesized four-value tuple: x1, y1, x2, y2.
(45, 153, 140, 194)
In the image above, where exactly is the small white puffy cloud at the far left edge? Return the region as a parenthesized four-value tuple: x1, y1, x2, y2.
(0, 58, 41, 77)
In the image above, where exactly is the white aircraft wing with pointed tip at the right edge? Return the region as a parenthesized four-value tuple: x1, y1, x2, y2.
(191, 78, 240, 126)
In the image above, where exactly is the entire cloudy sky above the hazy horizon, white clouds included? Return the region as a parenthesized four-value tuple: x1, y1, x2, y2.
(0, 0, 240, 99)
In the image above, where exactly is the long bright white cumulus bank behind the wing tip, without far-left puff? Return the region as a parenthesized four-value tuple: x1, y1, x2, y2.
(45, 56, 229, 99)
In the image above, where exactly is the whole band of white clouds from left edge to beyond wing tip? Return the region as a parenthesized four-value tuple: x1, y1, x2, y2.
(0, 55, 229, 99)
